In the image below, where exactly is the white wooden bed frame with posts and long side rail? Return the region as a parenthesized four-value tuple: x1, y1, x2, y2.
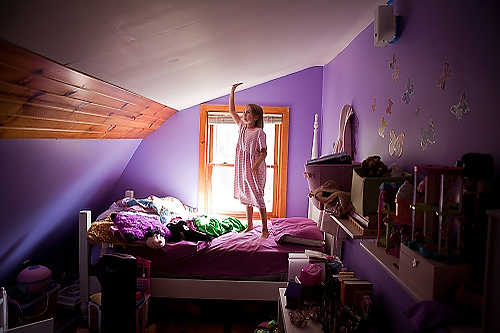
(78, 112, 332, 317)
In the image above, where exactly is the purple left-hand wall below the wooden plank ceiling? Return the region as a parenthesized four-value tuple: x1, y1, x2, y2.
(0, 139, 140, 285)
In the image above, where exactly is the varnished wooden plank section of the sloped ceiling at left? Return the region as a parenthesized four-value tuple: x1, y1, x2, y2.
(0, 39, 177, 139)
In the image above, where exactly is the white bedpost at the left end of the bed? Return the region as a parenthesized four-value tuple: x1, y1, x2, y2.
(78, 210, 92, 319)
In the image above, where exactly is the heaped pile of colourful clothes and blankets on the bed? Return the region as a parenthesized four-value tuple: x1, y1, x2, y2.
(88, 195, 247, 248)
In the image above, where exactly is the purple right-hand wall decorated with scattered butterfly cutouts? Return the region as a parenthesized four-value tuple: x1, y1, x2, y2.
(322, 0, 500, 170)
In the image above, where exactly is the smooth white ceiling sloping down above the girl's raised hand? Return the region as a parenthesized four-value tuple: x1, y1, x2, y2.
(0, 0, 385, 110)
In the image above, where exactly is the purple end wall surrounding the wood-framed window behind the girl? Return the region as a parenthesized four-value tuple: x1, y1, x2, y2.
(113, 67, 323, 216)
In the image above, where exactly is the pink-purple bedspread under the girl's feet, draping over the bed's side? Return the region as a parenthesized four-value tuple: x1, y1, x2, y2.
(125, 223, 319, 279)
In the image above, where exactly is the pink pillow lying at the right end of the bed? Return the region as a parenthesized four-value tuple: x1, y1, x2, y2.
(270, 217, 324, 247)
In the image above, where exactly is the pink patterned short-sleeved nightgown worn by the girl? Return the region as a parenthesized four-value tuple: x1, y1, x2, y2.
(234, 121, 267, 208)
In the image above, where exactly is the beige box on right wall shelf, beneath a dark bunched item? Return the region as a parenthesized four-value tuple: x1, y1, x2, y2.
(351, 168, 411, 216)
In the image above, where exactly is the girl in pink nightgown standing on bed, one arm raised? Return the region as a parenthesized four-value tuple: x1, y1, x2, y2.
(229, 83, 269, 238)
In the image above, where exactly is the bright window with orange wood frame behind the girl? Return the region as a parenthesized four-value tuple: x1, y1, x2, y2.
(198, 104, 289, 218)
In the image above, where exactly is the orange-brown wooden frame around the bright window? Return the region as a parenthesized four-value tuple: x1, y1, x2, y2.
(198, 104, 290, 218)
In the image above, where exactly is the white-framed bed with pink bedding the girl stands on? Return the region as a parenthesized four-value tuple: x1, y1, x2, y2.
(79, 193, 326, 313)
